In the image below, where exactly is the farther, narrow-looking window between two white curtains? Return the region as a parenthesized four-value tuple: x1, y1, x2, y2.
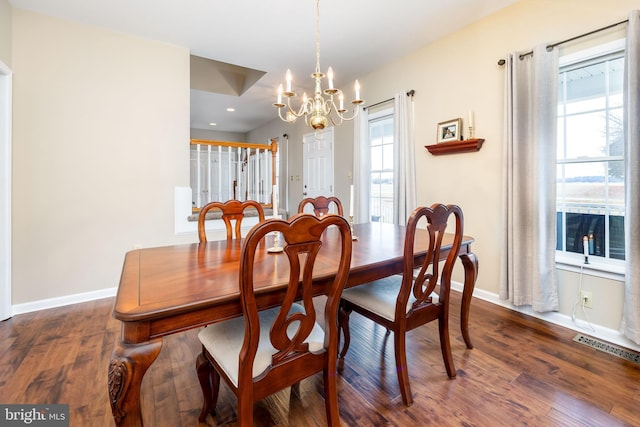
(369, 108, 395, 223)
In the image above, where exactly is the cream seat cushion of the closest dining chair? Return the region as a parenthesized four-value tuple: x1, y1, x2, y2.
(198, 304, 324, 386)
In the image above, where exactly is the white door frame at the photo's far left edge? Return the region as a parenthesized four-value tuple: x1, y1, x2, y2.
(0, 61, 13, 320)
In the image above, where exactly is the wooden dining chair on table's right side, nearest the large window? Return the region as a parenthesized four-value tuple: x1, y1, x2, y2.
(339, 203, 463, 406)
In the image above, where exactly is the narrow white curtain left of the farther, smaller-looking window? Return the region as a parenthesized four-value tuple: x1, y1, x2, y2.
(353, 108, 371, 224)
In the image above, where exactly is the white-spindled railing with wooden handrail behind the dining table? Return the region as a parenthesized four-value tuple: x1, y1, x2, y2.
(190, 139, 278, 211)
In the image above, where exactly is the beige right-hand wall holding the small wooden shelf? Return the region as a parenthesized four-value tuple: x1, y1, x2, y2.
(251, 0, 640, 329)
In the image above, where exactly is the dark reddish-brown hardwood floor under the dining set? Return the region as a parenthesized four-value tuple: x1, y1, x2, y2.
(0, 293, 640, 427)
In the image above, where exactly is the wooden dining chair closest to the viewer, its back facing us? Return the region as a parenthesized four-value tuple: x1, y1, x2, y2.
(196, 214, 352, 426)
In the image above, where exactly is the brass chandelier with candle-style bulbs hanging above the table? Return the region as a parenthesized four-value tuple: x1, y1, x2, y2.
(273, 0, 364, 130)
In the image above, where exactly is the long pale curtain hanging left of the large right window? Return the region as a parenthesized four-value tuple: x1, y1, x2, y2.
(500, 46, 559, 312)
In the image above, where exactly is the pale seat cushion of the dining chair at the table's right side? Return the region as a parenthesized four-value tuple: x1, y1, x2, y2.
(342, 274, 438, 321)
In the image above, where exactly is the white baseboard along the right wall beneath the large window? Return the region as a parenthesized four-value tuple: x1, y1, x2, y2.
(451, 281, 640, 351)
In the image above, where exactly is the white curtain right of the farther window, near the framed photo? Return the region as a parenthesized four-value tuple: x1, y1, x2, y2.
(393, 91, 417, 225)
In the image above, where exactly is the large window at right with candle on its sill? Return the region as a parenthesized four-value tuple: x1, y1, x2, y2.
(556, 42, 624, 263)
